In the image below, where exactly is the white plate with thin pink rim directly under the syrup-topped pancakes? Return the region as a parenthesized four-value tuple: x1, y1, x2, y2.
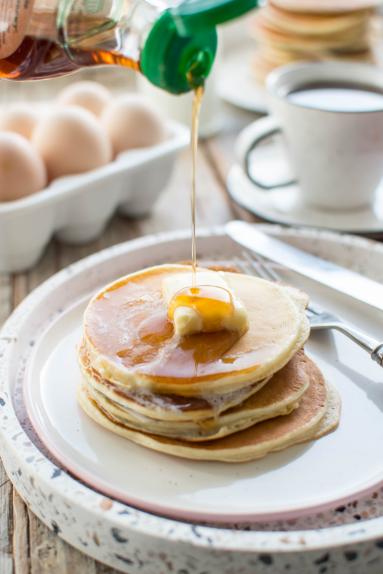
(24, 230, 383, 523)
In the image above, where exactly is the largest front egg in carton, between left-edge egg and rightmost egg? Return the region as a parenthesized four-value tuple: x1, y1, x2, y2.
(32, 107, 112, 180)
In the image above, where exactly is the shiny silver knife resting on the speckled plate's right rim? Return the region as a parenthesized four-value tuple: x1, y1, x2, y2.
(225, 221, 383, 311)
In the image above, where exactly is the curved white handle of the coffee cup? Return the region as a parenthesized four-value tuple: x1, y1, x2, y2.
(236, 116, 296, 191)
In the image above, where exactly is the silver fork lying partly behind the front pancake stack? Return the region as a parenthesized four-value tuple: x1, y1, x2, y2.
(237, 251, 383, 367)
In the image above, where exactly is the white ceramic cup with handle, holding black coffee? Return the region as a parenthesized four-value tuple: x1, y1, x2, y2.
(237, 62, 383, 210)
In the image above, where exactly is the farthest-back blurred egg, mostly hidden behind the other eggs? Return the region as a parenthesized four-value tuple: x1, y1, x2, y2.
(57, 82, 112, 116)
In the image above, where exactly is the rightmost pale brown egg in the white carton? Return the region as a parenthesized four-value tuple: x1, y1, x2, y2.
(101, 94, 166, 155)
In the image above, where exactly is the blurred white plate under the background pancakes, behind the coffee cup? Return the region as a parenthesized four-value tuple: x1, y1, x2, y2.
(217, 46, 268, 114)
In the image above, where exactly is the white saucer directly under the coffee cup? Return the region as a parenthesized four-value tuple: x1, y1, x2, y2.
(227, 140, 383, 235)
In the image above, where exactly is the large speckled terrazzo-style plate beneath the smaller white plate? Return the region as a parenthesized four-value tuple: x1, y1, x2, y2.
(0, 226, 383, 574)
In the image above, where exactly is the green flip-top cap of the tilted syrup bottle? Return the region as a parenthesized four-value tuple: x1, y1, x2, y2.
(140, 0, 257, 94)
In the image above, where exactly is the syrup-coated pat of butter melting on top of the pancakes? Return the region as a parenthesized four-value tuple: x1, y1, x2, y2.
(162, 270, 248, 336)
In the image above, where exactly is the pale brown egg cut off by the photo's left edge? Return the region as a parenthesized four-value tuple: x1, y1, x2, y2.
(0, 132, 47, 201)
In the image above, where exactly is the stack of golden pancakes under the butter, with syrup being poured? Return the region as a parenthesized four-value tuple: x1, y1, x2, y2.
(78, 265, 339, 462)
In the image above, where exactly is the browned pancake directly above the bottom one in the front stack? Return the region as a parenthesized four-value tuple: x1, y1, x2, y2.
(84, 351, 310, 441)
